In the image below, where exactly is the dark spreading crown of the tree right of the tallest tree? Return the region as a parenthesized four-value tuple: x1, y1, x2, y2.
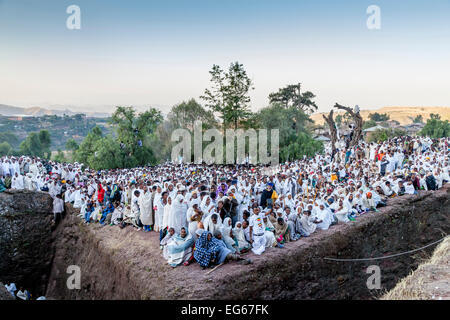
(269, 83, 317, 114)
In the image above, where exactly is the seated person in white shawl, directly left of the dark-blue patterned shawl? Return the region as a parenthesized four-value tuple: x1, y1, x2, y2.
(167, 227, 194, 268)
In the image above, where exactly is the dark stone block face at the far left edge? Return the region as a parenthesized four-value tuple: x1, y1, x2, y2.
(0, 191, 54, 294)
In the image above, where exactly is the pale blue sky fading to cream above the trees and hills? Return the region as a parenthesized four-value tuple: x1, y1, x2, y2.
(0, 0, 450, 112)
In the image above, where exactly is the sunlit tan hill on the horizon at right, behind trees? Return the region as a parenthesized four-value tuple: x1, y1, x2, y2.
(311, 107, 450, 125)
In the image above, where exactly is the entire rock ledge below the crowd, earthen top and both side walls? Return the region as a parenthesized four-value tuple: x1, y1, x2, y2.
(47, 185, 450, 300)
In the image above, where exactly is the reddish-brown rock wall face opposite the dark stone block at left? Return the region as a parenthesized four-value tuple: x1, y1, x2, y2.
(46, 204, 141, 300)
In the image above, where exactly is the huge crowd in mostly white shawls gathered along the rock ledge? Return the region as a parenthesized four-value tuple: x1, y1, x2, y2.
(0, 137, 450, 268)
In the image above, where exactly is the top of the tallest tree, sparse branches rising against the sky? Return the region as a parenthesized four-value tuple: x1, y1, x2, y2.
(200, 62, 254, 132)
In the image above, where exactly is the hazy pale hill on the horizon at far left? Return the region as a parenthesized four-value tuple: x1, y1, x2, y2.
(0, 104, 110, 118)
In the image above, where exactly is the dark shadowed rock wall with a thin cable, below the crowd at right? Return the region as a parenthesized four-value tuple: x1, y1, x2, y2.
(215, 186, 450, 299)
